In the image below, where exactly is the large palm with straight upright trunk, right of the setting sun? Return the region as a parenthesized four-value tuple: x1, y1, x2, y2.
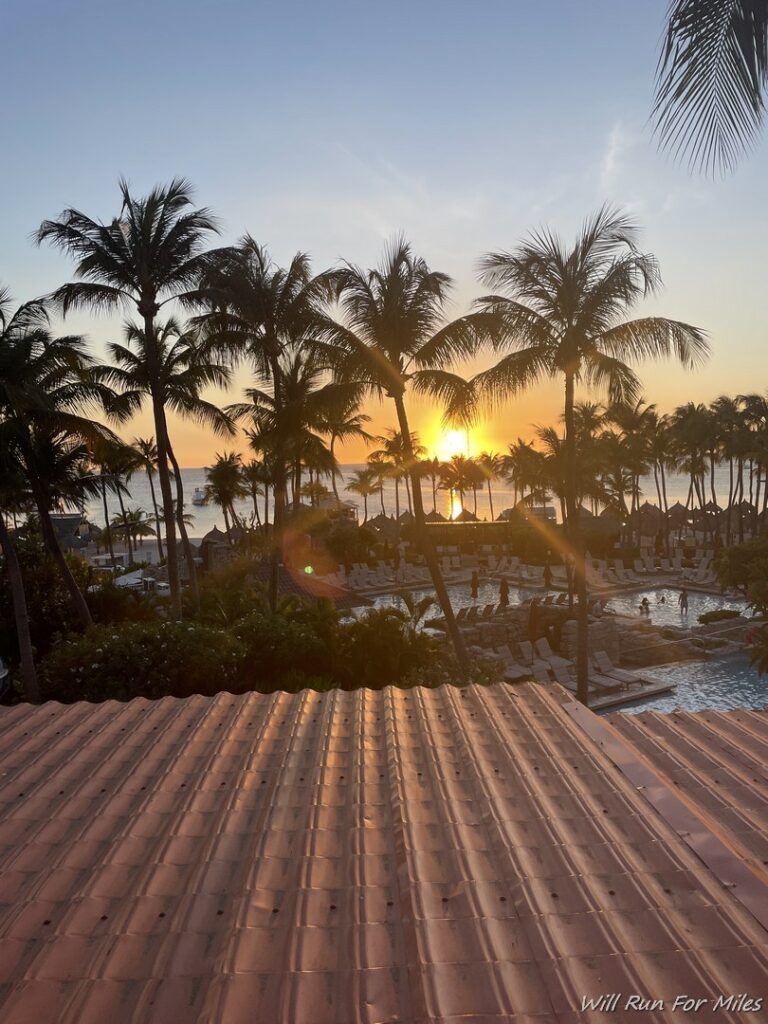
(475, 207, 708, 702)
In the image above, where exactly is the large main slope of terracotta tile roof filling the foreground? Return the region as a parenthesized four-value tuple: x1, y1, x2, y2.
(0, 685, 768, 1024)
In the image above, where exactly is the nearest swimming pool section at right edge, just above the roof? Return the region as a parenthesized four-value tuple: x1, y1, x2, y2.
(613, 653, 768, 715)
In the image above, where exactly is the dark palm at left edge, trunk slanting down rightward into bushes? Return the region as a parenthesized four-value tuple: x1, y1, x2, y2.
(0, 290, 115, 627)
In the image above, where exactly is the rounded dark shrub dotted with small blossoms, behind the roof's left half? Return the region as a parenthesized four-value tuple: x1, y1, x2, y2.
(40, 623, 243, 701)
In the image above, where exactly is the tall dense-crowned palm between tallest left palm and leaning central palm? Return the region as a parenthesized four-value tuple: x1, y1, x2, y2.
(200, 236, 325, 608)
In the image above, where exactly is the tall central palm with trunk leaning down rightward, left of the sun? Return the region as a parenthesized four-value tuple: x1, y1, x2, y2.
(326, 241, 490, 677)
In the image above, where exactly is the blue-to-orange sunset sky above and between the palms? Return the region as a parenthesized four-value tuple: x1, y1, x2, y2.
(0, 0, 768, 466)
